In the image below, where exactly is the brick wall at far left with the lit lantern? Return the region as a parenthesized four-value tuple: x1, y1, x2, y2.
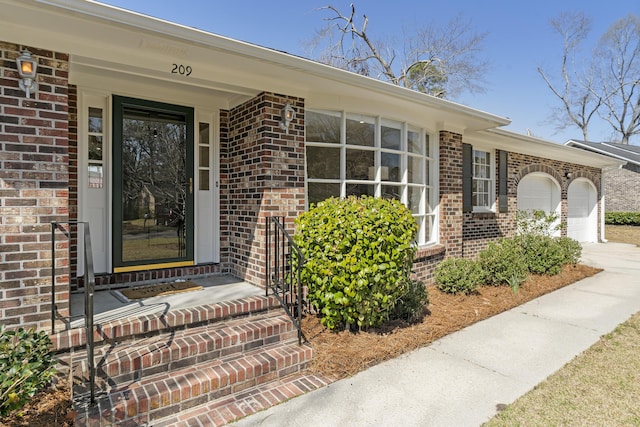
(0, 42, 69, 329)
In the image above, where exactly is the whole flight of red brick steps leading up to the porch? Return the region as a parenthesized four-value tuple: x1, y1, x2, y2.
(63, 297, 329, 426)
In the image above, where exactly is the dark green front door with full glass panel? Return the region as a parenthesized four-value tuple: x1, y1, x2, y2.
(112, 96, 194, 272)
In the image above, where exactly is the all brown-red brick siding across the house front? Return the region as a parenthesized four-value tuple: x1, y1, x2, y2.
(0, 37, 604, 329)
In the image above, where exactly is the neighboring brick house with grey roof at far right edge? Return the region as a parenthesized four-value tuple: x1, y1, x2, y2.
(565, 140, 640, 212)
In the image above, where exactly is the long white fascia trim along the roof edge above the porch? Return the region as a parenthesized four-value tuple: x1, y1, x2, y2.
(32, 0, 511, 128)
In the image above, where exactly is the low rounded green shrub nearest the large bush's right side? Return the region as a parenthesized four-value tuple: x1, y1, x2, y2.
(434, 258, 484, 294)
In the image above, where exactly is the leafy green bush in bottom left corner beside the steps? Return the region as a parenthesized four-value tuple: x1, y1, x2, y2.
(0, 325, 55, 417)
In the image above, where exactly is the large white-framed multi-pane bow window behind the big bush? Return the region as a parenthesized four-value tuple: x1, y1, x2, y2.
(305, 110, 437, 244)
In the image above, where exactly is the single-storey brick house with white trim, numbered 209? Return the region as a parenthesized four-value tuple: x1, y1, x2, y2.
(0, 0, 622, 328)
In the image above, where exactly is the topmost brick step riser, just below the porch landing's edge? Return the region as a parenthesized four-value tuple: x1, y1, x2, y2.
(73, 322, 297, 392)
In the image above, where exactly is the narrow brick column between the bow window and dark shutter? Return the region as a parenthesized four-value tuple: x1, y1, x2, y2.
(440, 131, 463, 258)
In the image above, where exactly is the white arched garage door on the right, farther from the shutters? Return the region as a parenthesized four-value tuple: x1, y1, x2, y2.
(567, 180, 598, 242)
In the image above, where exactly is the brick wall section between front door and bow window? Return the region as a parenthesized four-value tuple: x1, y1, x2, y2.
(220, 93, 305, 285)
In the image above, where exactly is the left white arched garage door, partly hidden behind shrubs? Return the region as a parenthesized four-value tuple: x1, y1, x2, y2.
(518, 174, 560, 235)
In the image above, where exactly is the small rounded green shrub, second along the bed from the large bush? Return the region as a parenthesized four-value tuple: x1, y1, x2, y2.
(478, 238, 529, 287)
